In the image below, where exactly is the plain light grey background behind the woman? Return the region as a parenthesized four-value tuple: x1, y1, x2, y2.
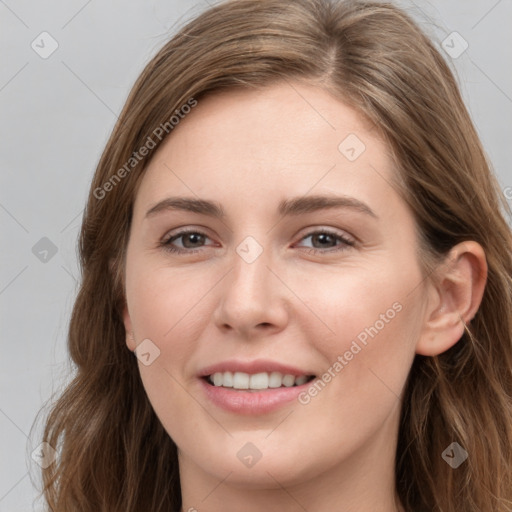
(0, 0, 512, 512)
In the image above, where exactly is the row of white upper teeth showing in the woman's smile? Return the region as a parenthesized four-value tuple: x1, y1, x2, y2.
(208, 372, 309, 389)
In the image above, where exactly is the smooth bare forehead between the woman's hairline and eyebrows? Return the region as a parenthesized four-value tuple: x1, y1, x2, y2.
(132, 82, 400, 220)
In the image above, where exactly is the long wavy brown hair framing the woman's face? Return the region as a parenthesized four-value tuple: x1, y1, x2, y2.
(33, 0, 512, 512)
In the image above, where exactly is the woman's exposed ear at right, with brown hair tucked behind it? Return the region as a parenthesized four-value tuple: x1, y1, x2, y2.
(416, 241, 487, 356)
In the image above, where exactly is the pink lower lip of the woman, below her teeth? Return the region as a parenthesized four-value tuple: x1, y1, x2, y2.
(199, 379, 311, 415)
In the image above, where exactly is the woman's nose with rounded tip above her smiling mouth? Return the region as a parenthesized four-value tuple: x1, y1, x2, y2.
(213, 241, 291, 339)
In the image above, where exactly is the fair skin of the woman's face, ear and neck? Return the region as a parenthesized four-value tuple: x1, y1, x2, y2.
(124, 83, 486, 512)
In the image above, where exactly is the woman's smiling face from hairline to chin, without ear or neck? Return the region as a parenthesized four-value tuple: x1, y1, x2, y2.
(124, 84, 424, 488)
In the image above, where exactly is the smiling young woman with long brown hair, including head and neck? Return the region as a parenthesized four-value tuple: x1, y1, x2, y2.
(33, 0, 512, 512)
